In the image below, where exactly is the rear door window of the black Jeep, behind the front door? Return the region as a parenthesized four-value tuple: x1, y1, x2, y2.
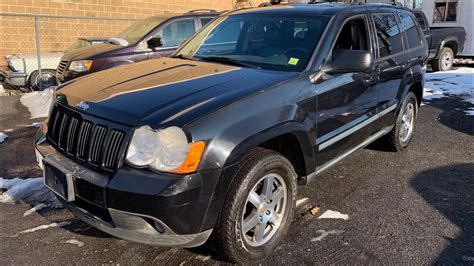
(373, 15, 402, 57)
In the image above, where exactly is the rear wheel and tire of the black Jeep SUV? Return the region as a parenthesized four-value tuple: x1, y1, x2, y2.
(382, 92, 418, 152)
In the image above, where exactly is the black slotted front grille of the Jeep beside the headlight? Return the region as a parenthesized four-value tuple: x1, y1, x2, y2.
(48, 105, 127, 171)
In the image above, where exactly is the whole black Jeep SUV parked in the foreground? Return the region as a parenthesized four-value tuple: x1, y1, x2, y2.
(36, 4, 427, 263)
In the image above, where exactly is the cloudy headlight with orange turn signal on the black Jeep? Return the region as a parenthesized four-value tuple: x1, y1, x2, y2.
(126, 126, 205, 174)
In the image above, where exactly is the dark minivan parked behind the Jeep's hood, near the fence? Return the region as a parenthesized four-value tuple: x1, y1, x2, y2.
(56, 9, 219, 83)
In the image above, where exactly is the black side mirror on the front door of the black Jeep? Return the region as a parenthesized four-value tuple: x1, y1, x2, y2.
(323, 49, 374, 74)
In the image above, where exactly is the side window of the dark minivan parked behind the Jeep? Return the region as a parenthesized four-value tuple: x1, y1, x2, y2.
(154, 18, 196, 48)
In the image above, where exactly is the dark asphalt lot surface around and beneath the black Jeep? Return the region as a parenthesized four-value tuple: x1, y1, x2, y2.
(0, 91, 474, 265)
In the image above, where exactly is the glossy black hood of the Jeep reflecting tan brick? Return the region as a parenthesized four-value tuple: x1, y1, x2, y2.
(57, 58, 297, 128)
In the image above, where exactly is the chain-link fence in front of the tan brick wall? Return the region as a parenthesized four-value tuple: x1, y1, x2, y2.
(0, 13, 138, 91)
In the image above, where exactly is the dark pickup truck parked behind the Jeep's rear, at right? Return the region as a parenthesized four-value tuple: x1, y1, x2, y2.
(414, 11, 466, 71)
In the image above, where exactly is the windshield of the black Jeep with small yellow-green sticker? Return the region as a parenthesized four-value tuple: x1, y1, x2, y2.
(175, 15, 329, 71)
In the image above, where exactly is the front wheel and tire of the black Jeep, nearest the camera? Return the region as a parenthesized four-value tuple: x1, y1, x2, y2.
(215, 148, 297, 264)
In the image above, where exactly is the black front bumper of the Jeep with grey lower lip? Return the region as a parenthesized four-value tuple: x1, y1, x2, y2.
(36, 143, 221, 247)
